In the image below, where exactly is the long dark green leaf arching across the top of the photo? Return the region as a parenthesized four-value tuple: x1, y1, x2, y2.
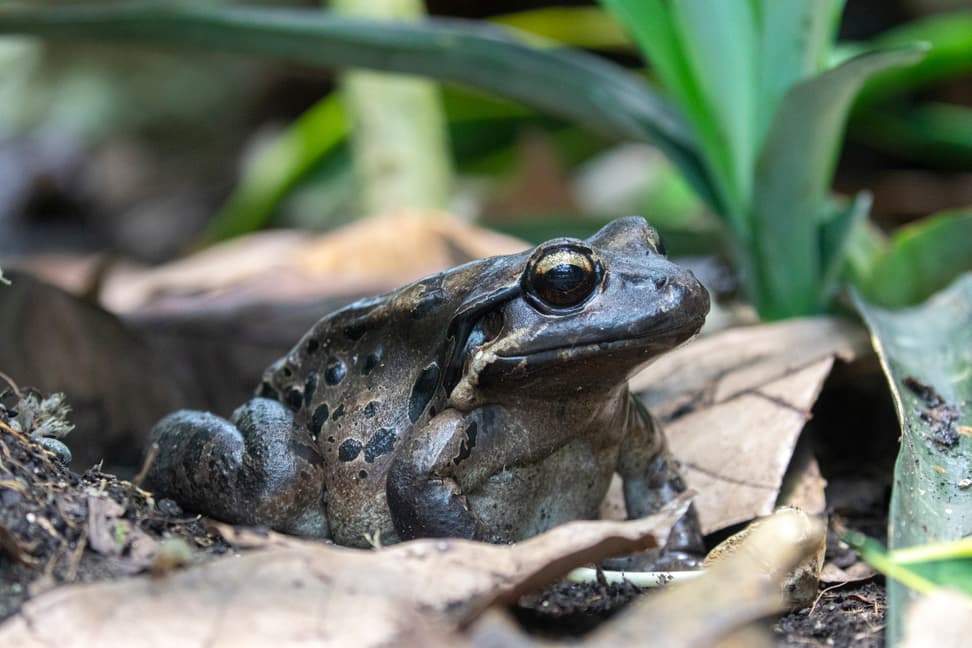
(0, 3, 718, 205)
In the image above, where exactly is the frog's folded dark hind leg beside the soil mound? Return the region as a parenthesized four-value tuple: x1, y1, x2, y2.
(146, 398, 329, 537)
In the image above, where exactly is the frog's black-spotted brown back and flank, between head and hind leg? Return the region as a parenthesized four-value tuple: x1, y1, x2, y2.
(258, 266, 486, 545)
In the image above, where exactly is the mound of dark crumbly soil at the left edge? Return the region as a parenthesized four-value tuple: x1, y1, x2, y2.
(0, 400, 229, 620)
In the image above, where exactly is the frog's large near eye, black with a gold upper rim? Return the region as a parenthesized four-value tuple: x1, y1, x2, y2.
(523, 244, 601, 309)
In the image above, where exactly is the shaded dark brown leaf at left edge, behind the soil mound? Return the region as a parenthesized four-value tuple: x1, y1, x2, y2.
(0, 271, 189, 468)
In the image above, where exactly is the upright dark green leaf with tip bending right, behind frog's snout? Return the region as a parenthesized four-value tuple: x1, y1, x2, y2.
(747, 46, 924, 319)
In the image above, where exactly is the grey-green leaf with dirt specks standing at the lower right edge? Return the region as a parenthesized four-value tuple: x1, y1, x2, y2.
(855, 274, 972, 645)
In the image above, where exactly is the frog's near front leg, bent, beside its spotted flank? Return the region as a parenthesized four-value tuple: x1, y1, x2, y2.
(385, 409, 490, 541)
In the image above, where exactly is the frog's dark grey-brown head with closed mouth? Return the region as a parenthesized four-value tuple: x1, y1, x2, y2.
(446, 217, 709, 404)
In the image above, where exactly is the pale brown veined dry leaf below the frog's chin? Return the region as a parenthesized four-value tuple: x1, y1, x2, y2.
(631, 317, 868, 533)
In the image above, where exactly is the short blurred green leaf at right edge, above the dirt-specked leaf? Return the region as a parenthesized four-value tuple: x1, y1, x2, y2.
(860, 210, 972, 308)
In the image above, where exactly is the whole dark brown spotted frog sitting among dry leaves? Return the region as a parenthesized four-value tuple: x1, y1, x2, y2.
(148, 217, 709, 555)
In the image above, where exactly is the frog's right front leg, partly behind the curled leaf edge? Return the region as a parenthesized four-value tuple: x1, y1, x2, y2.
(618, 396, 705, 569)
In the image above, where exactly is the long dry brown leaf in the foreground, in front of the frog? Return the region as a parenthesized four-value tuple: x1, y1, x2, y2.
(0, 498, 688, 648)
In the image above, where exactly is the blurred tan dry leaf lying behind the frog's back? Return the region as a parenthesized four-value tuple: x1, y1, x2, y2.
(102, 212, 528, 313)
